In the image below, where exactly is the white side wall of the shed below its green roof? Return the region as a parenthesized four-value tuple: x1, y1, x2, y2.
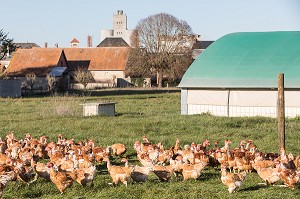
(181, 89, 300, 117)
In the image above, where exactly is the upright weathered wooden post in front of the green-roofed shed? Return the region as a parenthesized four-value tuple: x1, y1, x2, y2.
(277, 73, 285, 148)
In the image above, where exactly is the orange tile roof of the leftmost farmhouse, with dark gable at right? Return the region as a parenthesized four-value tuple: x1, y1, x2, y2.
(6, 48, 63, 76)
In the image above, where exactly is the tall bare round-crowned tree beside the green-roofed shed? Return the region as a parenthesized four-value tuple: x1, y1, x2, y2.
(127, 13, 193, 87)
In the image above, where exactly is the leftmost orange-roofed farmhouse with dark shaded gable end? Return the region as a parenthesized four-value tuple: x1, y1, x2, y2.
(6, 48, 68, 89)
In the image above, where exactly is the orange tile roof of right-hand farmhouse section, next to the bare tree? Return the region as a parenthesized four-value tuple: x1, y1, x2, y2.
(64, 47, 130, 71)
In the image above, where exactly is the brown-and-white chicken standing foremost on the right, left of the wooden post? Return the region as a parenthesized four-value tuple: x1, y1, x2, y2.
(221, 166, 247, 193)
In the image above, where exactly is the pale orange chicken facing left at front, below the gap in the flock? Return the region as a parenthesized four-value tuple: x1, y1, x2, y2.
(103, 158, 132, 187)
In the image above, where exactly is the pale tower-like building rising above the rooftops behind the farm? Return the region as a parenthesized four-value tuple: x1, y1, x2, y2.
(100, 10, 133, 46)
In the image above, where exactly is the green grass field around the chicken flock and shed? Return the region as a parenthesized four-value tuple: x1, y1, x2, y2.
(0, 89, 300, 199)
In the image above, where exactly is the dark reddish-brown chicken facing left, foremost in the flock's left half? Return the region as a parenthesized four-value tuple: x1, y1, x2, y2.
(47, 162, 73, 194)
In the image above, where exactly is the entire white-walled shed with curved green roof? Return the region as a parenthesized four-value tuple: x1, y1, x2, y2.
(179, 31, 300, 117)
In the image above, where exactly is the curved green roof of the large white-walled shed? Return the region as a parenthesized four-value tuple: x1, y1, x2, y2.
(179, 31, 300, 88)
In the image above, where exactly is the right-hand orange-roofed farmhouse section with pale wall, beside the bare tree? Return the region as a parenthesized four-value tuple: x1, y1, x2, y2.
(64, 47, 130, 88)
